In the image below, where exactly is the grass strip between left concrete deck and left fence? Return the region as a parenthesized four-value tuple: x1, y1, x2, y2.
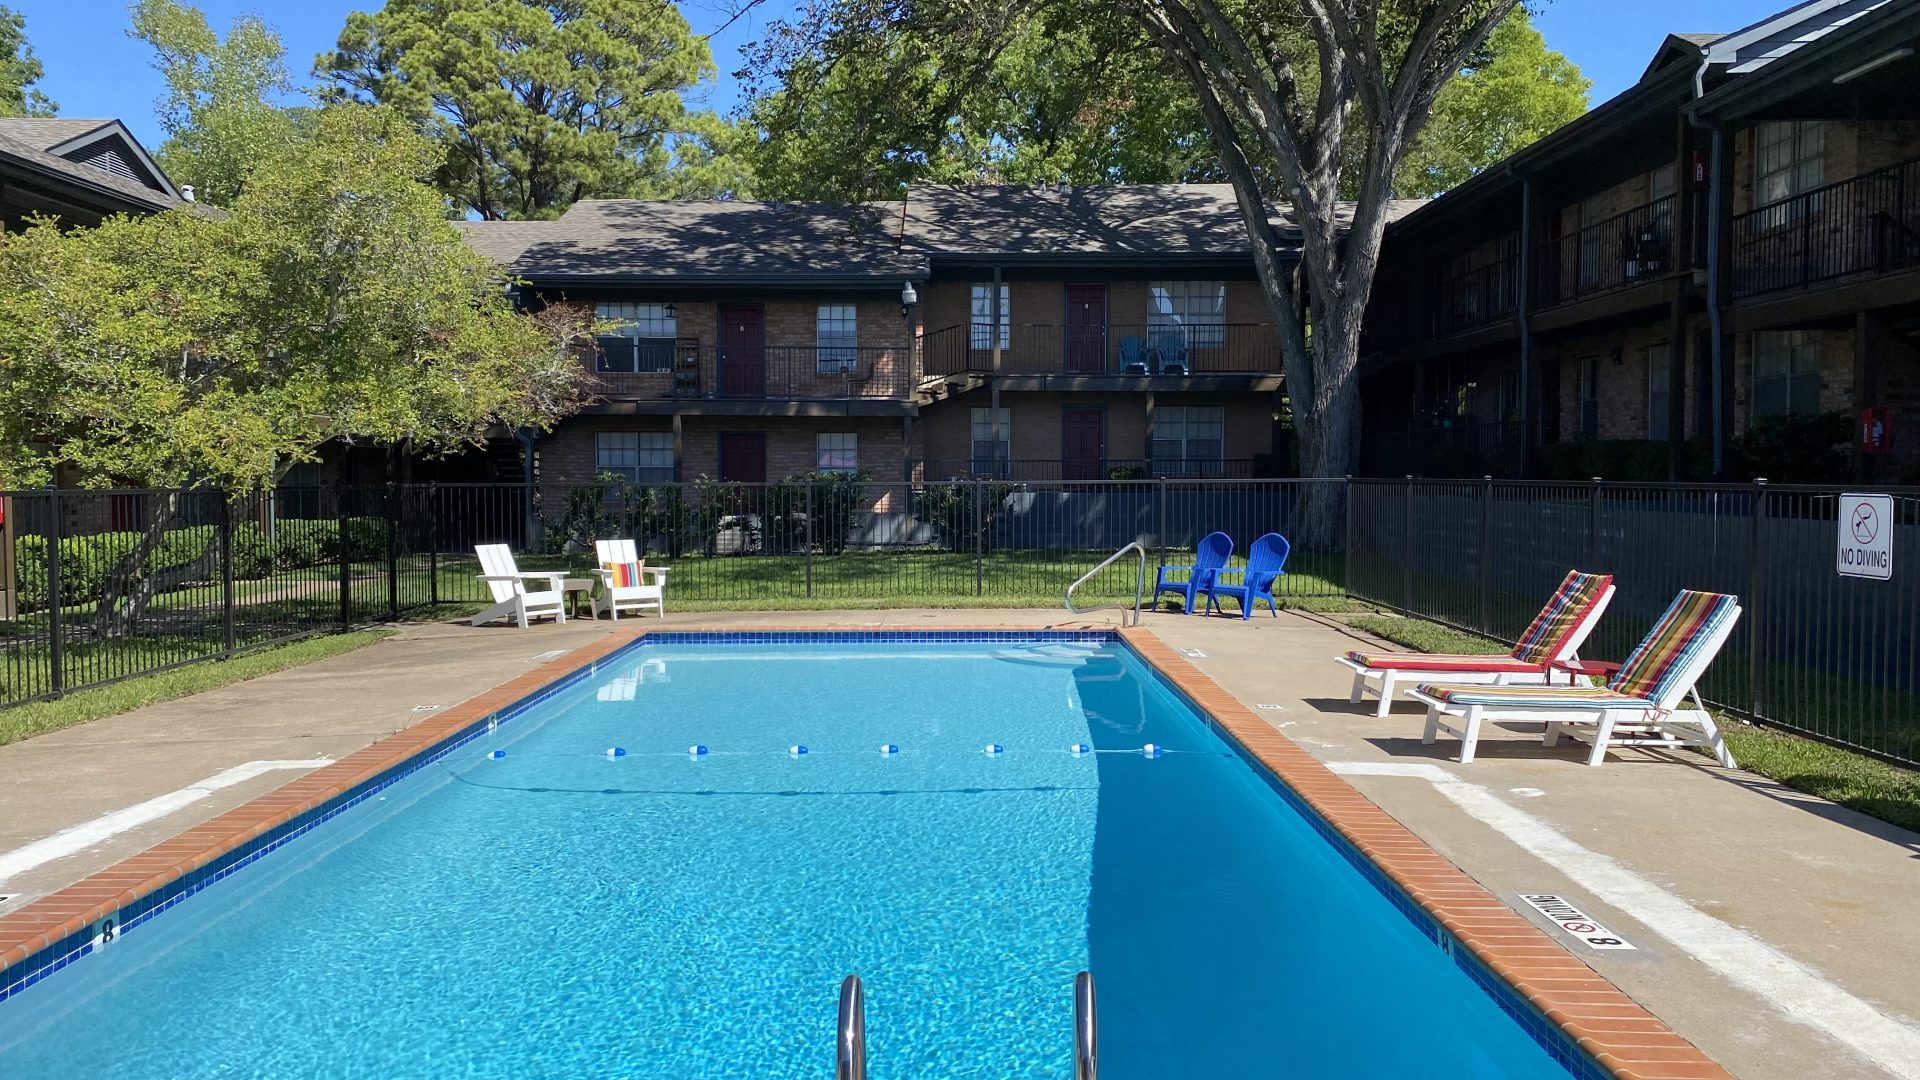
(0, 630, 392, 746)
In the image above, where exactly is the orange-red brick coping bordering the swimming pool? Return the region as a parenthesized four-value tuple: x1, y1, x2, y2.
(0, 626, 1732, 1080)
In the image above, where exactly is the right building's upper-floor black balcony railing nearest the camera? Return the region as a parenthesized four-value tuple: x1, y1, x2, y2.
(1728, 151, 1920, 298)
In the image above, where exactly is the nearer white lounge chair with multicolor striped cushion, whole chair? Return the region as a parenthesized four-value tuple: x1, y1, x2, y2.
(1411, 592, 1740, 769)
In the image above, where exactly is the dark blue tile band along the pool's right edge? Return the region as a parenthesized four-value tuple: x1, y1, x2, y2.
(1114, 634, 1615, 1080)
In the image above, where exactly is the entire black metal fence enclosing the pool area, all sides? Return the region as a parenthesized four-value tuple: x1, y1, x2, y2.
(0, 479, 1920, 763)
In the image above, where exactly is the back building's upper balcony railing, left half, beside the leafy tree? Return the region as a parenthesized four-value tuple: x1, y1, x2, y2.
(593, 338, 918, 402)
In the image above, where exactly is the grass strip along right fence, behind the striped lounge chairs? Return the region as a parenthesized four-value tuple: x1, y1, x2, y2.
(1348, 615, 1920, 832)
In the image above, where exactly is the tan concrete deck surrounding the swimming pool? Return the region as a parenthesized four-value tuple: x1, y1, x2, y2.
(0, 609, 1920, 1080)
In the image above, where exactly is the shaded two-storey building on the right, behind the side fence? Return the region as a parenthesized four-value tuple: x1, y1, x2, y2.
(1361, 0, 1920, 480)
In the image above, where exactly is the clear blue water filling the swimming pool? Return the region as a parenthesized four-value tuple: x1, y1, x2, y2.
(0, 642, 1567, 1080)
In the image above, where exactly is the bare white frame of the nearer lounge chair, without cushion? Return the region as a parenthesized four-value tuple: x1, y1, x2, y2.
(1407, 605, 1741, 769)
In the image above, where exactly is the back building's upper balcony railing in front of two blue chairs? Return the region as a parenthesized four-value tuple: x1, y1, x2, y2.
(922, 323, 1281, 377)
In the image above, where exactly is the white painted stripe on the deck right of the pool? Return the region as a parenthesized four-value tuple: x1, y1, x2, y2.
(1327, 761, 1920, 1080)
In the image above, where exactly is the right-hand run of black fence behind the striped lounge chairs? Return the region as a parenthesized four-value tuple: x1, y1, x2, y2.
(1346, 480, 1920, 763)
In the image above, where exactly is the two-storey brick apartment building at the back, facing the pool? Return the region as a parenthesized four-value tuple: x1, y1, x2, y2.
(461, 184, 1313, 484)
